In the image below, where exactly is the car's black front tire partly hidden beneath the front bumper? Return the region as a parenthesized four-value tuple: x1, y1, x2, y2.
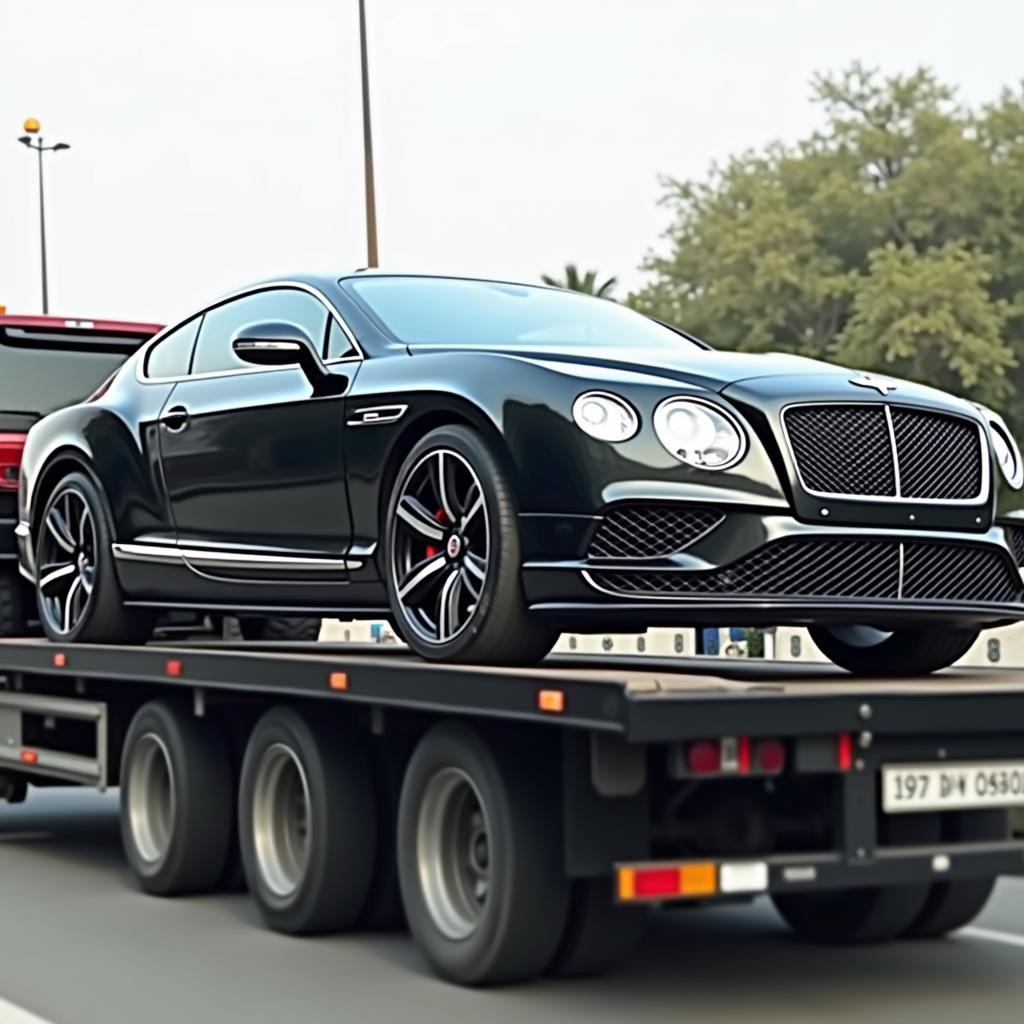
(809, 626, 980, 676)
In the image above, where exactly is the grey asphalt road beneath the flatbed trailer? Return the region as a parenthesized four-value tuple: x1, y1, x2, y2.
(0, 791, 1024, 1024)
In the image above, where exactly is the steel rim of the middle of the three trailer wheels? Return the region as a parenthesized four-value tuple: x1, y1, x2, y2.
(253, 743, 312, 899)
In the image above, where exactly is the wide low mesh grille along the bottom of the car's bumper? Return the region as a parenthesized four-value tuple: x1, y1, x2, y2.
(592, 538, 1024, 604)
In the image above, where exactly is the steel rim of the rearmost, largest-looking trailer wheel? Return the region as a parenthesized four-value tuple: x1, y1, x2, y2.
(416, 768, 493, 942)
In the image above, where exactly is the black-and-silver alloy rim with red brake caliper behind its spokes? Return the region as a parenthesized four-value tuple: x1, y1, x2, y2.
(389, 449, 490, 645)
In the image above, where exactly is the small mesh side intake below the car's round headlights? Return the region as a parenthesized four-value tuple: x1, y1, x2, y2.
(588, 505, 725, 558)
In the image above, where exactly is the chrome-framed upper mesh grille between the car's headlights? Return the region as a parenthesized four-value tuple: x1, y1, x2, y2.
(783, 402, 985, 502)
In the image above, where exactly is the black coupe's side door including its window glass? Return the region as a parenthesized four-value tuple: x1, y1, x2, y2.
(160, 288, 357, 582)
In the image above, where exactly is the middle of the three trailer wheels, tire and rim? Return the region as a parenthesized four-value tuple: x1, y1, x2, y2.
(239, 707, 377, 935)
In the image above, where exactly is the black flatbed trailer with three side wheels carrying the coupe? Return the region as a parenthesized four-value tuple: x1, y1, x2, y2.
(0, 639, 1024, 984)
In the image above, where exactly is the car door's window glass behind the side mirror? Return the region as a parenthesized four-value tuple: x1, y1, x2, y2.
(191, 288, 328, 374)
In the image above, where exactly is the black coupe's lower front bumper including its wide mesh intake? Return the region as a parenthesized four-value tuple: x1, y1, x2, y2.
(523, 506, 1024, 632)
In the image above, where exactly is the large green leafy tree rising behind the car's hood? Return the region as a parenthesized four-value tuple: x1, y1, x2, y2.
(630, 65, 1024, 413)
